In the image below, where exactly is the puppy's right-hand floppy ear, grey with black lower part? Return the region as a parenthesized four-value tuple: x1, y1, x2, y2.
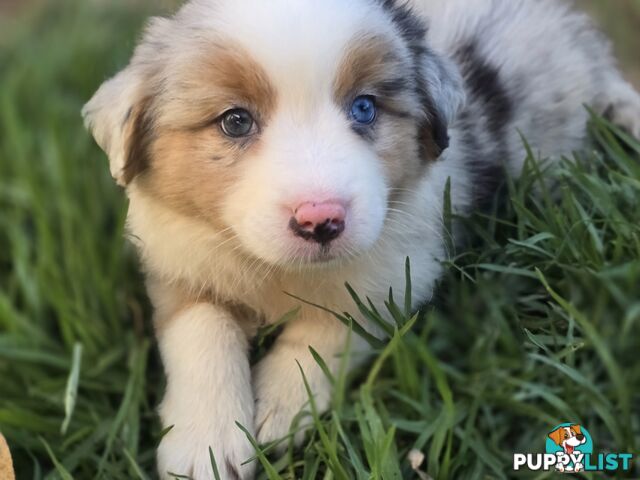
(422, 50, 466, 158)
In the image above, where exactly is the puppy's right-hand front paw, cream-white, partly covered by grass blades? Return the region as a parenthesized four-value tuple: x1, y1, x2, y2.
(253, 349, 331, 444)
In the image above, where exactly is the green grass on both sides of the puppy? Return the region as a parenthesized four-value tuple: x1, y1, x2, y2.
(0, 2, 640, 479)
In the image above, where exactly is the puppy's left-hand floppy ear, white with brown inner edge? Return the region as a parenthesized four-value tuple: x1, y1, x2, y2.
(82, 66, 153, 187)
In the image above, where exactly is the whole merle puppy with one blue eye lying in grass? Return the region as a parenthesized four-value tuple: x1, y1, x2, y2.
(83, 0, 640, 480)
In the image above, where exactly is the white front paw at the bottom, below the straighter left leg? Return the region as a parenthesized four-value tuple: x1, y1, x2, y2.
(158, 425, 255, 480)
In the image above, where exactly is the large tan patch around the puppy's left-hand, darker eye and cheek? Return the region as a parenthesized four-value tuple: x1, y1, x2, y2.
(134, 40, 276, 230)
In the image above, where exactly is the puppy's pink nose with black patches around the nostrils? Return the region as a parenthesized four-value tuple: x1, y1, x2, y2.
(289, 201, 347, 245)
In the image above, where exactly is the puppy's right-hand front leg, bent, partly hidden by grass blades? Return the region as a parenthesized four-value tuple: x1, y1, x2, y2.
(253, 314, 364, 444)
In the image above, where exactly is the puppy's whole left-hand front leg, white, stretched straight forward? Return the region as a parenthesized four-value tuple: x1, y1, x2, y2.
(158, 304, 254, 480)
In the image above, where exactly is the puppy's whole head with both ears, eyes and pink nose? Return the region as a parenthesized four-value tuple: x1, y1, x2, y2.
(83, 0, 463, 267)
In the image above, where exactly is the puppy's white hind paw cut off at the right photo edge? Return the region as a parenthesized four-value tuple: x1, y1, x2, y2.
(596, 74, 640, 139)
